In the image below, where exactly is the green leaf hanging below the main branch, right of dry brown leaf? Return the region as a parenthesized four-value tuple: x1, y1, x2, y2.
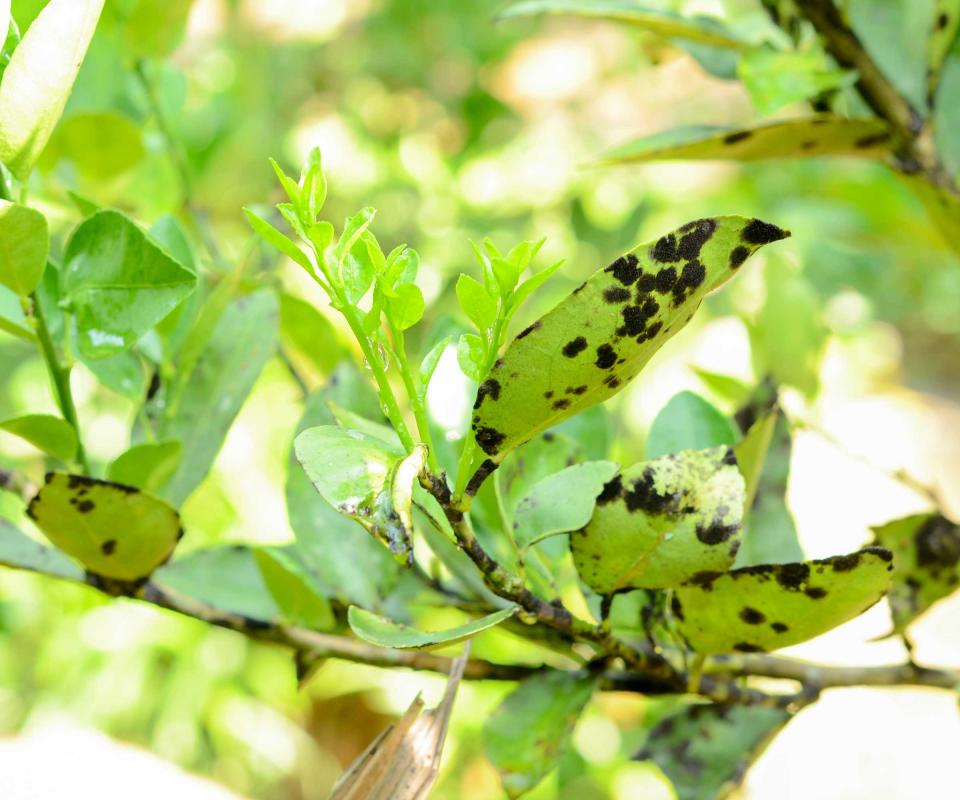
(483, 672, 596, 797)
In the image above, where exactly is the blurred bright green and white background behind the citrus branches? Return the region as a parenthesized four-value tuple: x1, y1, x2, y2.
(0, 0, 960, 800)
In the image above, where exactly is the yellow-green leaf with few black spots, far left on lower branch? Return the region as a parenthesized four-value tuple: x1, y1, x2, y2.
(27, 472, 183, 581)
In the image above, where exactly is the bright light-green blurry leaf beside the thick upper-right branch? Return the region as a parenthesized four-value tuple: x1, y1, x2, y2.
(737, 45, 856, 116)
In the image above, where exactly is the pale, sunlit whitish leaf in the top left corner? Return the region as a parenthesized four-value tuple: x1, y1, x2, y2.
(0, 0, 104, 180)
